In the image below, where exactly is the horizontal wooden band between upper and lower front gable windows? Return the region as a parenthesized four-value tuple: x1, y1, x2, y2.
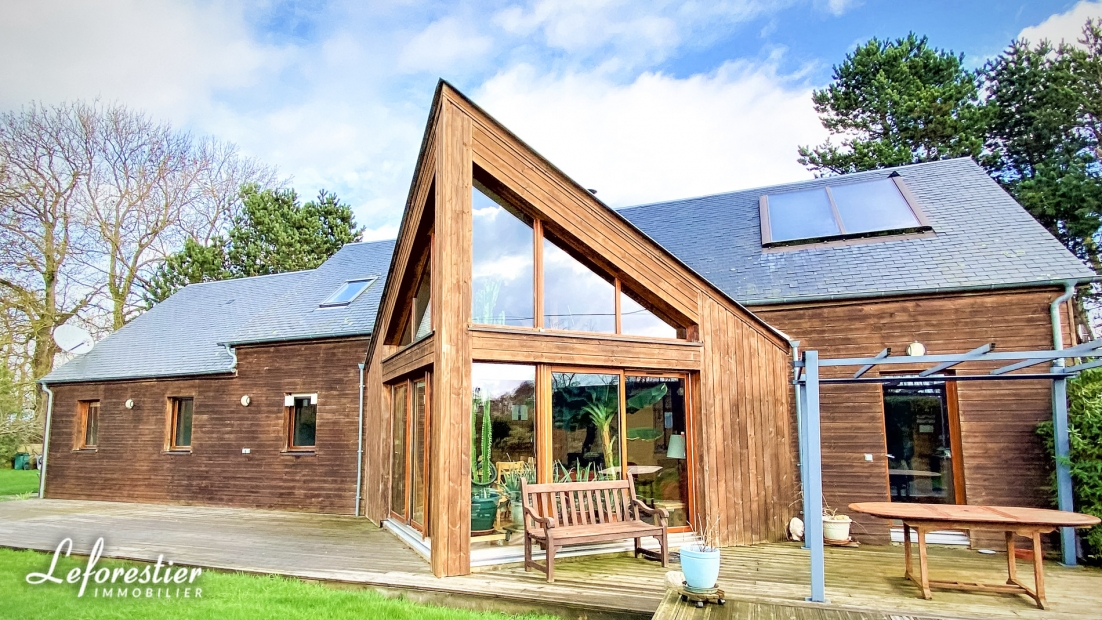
(471, 327, 704, 370)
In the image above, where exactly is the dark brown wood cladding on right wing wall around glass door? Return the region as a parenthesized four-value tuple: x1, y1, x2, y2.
(754, 289, 1070, 542)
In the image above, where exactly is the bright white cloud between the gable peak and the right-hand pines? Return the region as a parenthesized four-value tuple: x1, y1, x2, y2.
(474, 62, 825, 206)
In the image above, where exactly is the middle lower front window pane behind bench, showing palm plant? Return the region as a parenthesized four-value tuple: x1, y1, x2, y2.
(551, 372, 620, 482)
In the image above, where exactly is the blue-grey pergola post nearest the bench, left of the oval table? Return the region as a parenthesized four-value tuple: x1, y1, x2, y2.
(800, 351, 827, 602)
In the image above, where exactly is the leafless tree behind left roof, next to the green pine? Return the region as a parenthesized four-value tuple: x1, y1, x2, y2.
(86, 106, 274, 329)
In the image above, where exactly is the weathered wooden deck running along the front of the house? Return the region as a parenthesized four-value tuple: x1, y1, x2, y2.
(0, 500, 1102, 620)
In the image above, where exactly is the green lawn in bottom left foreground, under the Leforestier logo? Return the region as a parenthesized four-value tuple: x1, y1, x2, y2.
(0, 548, 551, 620)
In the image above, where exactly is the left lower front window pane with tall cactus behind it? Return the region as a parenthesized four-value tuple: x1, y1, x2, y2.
(471, 363, 537, 543)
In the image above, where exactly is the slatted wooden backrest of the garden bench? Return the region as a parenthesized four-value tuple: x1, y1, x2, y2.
(520, 474, 635, 527)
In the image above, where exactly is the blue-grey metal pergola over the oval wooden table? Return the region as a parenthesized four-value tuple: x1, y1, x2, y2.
(792, 339, 1102, 602)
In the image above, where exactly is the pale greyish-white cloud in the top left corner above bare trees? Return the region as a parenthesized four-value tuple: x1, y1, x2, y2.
(0, 0, 289, 121)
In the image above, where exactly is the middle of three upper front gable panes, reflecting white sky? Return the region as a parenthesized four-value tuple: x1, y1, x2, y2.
(543, 239, 616, 334)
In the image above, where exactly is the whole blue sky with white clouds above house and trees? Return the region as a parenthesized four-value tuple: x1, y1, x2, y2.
(0, 0, 1102, 240)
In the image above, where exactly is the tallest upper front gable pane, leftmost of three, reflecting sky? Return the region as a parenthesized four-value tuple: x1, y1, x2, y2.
(472, 187, 536, 327)
